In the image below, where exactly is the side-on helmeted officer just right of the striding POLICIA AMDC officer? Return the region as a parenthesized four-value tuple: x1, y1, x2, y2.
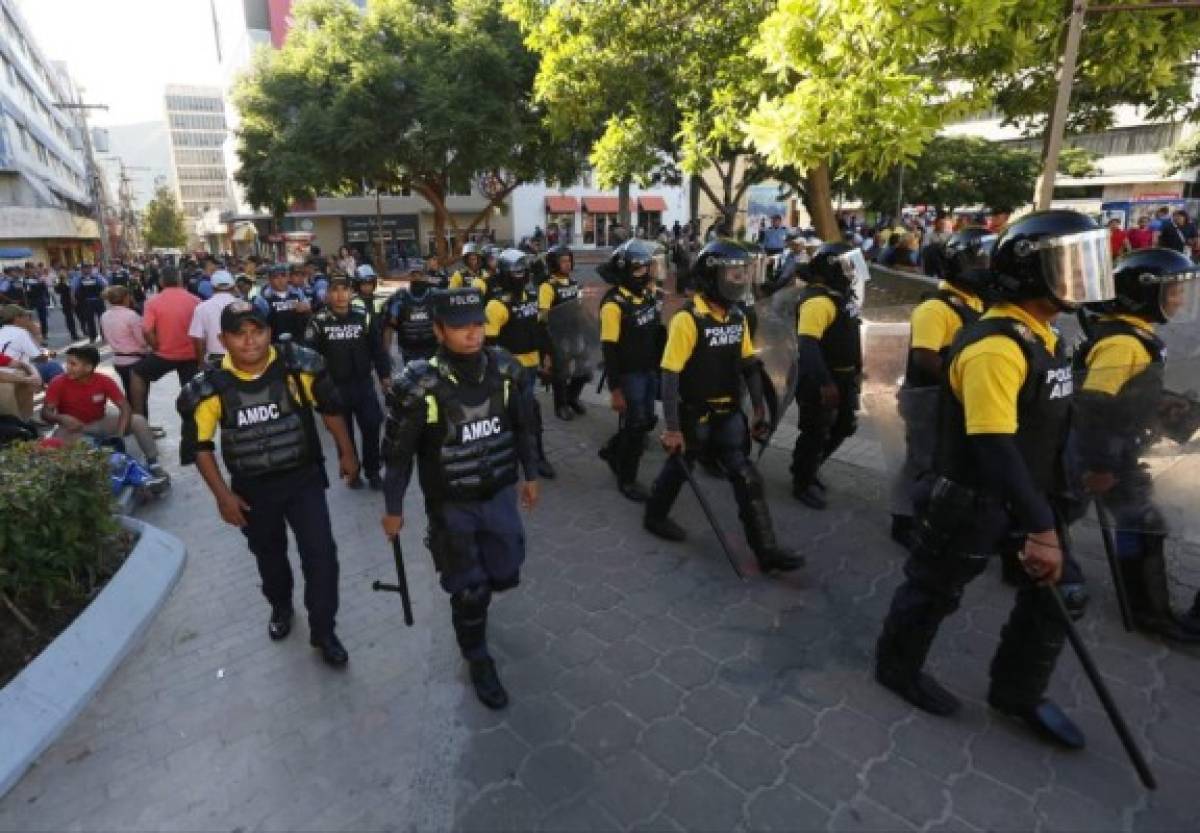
(792, 242, 866, 509)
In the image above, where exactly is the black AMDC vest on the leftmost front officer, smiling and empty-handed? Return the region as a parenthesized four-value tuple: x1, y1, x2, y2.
(214, 359, 318, 478)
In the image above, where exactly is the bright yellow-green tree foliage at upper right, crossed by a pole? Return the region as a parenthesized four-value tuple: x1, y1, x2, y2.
(746, 0, 1200, 225)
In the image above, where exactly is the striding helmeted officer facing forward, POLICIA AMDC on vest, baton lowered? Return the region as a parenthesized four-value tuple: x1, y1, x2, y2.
(643, 239, 804, 573)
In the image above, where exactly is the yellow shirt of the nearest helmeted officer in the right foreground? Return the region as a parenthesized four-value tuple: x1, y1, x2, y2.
(949, 304, 1058, 435)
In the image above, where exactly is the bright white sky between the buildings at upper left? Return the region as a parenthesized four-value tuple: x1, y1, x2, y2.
(17, 0, 218, 126)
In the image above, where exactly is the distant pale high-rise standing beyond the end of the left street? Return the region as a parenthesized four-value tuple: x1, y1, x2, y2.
(164, 84, 232, 236)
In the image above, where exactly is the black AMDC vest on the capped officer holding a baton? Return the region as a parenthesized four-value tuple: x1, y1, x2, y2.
(420, 350, 517, 502)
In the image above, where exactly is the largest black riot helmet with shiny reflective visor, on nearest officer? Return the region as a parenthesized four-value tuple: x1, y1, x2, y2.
(990, 209, 1116, 310)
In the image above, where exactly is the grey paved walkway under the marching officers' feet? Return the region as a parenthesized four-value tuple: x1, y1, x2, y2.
(0, 304, 1200, 831)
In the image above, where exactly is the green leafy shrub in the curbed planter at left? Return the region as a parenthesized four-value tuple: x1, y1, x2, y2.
(0, 443, 124, 609)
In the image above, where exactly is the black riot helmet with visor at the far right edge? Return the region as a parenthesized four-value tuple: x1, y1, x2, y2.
(1087, 248, 1200, 324)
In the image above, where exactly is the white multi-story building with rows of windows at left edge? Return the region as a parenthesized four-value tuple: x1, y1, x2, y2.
(0, 0, 103, 263)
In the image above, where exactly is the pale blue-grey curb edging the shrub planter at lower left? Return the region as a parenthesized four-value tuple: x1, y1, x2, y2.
(0, 517, 187, 797)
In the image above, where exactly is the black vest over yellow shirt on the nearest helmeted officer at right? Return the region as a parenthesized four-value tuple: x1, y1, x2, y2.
(935, 318, 1074, 492)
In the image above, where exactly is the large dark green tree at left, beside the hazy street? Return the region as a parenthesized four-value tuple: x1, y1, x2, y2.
(235, 0, 582, 254)
